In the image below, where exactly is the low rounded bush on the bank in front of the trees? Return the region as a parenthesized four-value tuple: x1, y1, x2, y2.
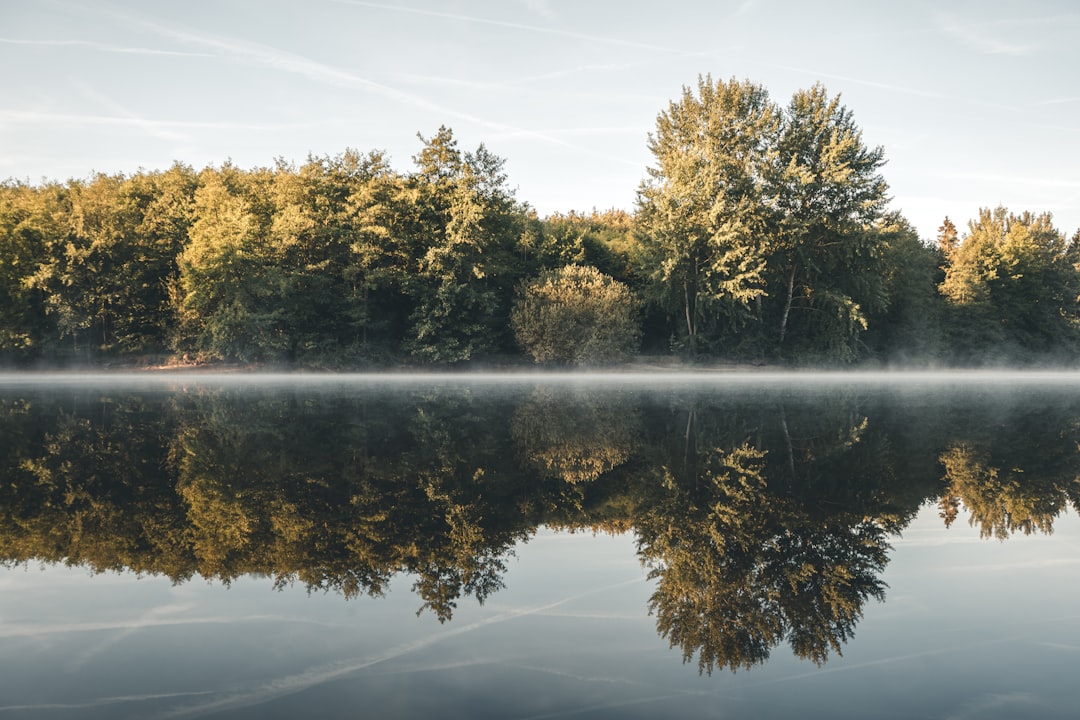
(511, 264, 640, 365)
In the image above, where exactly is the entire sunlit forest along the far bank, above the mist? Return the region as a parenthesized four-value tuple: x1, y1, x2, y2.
(0, 76, 1080, 368)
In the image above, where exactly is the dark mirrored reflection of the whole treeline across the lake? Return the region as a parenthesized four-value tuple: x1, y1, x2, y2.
(0, 383, 1080, 673)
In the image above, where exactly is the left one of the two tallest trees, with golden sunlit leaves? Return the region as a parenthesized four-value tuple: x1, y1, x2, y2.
(637, 76, 779, 354)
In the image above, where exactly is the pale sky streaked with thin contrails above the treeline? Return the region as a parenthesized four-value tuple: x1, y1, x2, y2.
(0, 0, 1080, 241)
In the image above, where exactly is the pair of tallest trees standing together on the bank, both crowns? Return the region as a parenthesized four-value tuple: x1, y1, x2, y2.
(638, 77, 887, 361)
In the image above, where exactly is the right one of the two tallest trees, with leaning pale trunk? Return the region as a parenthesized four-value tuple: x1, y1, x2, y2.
(767, 84, 888, 359)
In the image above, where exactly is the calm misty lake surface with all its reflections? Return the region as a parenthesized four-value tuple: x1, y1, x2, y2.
(0, 373, 1080, 719)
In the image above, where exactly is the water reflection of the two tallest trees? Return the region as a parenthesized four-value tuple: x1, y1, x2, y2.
(635, 397, 889, 674)
